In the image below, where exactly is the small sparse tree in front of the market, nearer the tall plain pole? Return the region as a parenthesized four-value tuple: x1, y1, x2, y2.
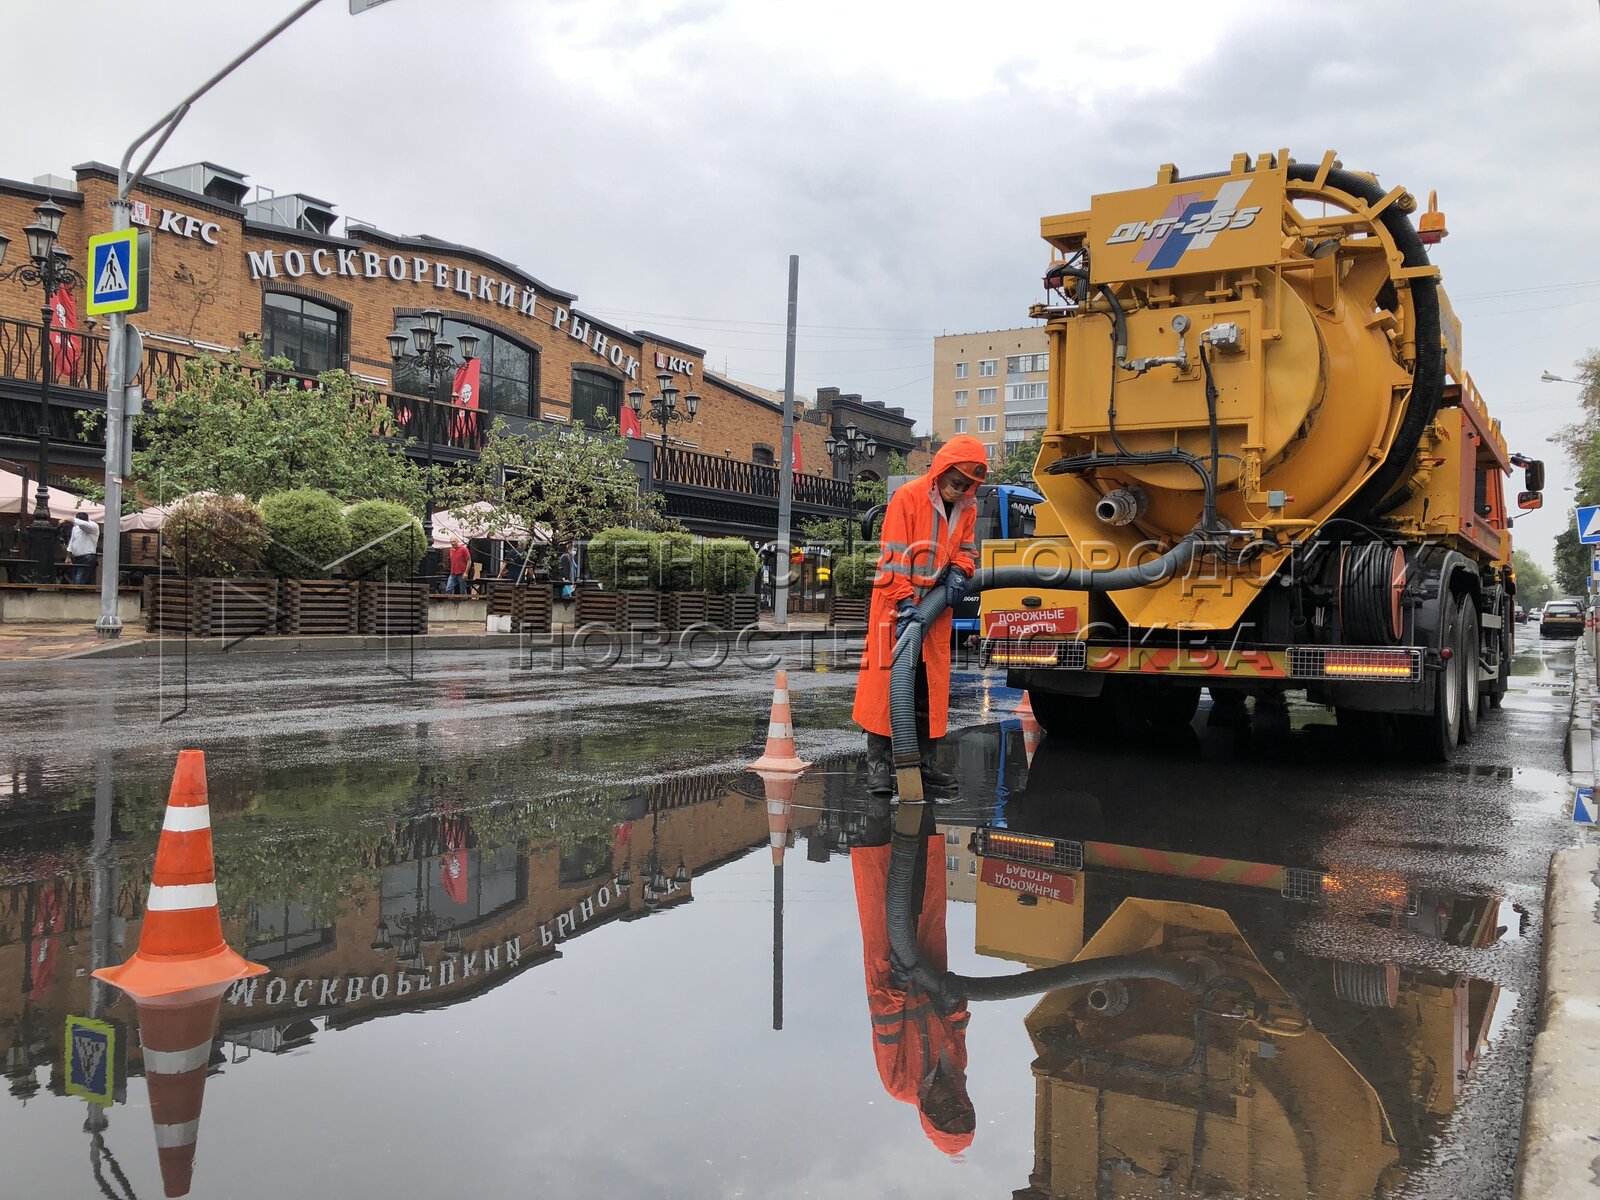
(440, 418, 662, 570)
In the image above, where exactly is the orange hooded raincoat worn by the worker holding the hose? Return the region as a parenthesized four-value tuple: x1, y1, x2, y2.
(851, 434, 989, 738)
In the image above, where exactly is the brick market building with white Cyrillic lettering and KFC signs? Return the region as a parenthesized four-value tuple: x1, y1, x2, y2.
(0, 162, 926, 539)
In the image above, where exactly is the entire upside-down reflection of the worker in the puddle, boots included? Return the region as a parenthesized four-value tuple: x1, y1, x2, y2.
(850, 814, 976, 1154)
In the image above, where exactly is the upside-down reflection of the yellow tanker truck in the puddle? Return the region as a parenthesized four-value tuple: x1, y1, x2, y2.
(971, 741, 1520, 1200)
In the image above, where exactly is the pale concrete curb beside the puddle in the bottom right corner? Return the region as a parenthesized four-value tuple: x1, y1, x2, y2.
(1517, 846, 1600, 1200)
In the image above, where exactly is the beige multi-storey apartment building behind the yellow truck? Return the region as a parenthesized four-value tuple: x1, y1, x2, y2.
(933, 325, 1050, 462)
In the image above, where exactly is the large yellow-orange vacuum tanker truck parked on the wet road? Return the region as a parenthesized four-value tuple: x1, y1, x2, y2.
(982, 152, 1542, 758)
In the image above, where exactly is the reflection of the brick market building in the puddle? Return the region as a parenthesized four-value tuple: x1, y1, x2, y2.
(0, 774, 826, 1096)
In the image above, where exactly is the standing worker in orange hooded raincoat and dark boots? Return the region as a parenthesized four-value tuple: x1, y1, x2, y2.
(853, 434, 989, 797)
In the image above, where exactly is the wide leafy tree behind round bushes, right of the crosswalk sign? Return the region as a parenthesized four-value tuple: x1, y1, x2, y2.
(85, 357, 422, 512)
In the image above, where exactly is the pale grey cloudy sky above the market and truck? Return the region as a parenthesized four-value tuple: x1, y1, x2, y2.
(0, 0, 1600, 560)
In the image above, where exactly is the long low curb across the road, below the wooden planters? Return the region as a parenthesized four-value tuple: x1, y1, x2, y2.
(50, 629, 862, 662)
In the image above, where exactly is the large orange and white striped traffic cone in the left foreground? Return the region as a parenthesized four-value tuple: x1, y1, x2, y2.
(94, 750, 267, 1000)
